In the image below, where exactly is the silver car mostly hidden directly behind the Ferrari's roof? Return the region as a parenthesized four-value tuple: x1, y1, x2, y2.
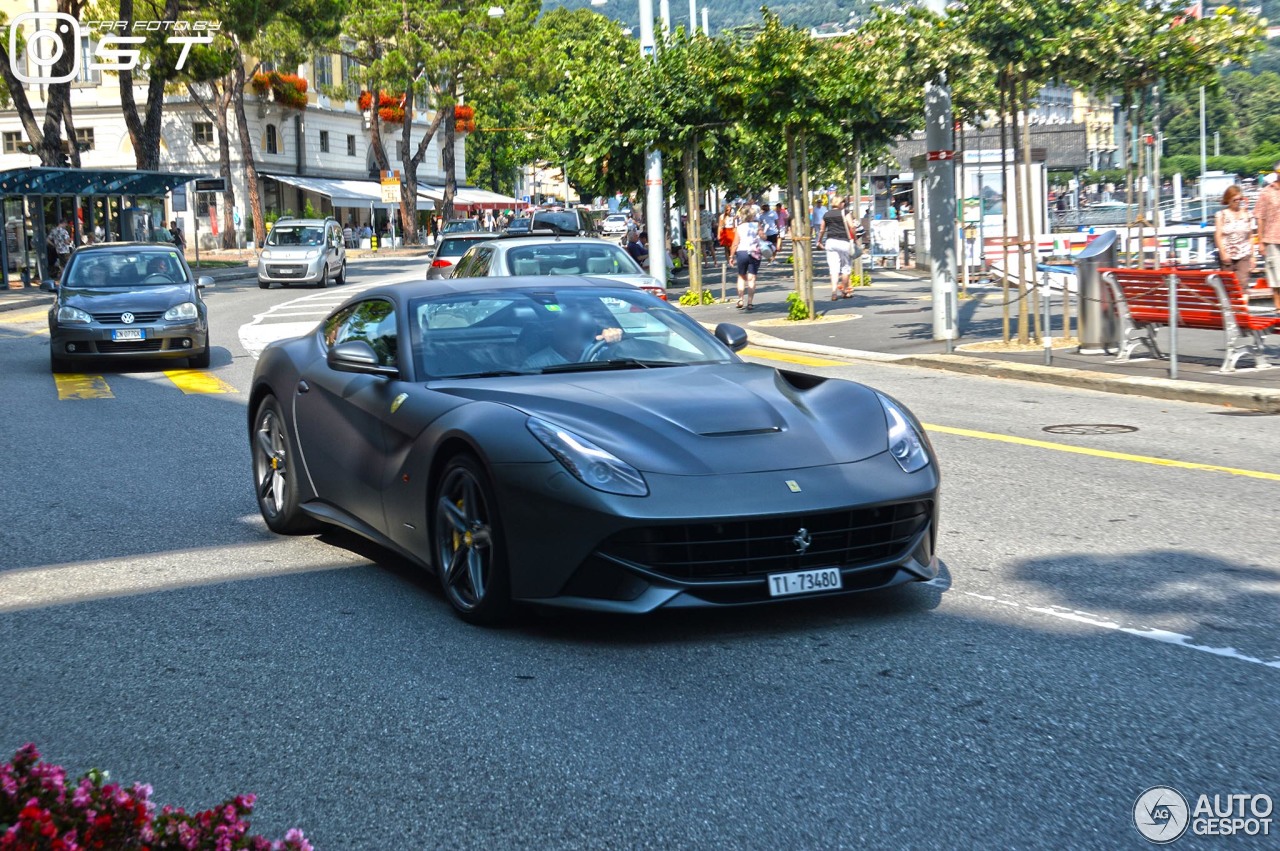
(449, 237, 667, 299)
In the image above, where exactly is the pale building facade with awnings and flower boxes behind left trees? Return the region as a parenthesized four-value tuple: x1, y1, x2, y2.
(0, 0, 466, 255)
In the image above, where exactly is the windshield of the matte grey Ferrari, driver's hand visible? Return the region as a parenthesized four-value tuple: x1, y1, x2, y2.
(410, 287, 737, 379)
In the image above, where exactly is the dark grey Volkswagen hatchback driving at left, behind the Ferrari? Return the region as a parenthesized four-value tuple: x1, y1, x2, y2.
(45, 242, 214, 372)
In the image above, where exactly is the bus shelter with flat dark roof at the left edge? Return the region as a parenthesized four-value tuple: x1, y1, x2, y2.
(0, 166, 210, 288)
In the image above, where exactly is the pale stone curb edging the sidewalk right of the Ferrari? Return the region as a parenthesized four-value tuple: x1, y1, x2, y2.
(703, 322, 1280, 413)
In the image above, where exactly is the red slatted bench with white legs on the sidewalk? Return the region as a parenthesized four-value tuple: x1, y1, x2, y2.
(1102, 269, 1280, 372)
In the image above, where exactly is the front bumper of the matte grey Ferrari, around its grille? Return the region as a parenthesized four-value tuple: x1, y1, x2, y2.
(495, 453, 938, 613)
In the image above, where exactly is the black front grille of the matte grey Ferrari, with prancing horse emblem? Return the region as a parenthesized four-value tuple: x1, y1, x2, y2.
(599, 500, 933, 580)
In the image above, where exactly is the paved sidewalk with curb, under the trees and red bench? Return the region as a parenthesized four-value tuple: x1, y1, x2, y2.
(668, 236, 1280, 413)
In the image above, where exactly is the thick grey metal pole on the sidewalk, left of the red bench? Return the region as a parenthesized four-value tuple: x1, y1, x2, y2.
(924, 0, 957, 352)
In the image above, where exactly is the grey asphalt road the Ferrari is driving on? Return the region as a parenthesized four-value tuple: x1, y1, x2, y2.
(0, 260, 1280, 848)
